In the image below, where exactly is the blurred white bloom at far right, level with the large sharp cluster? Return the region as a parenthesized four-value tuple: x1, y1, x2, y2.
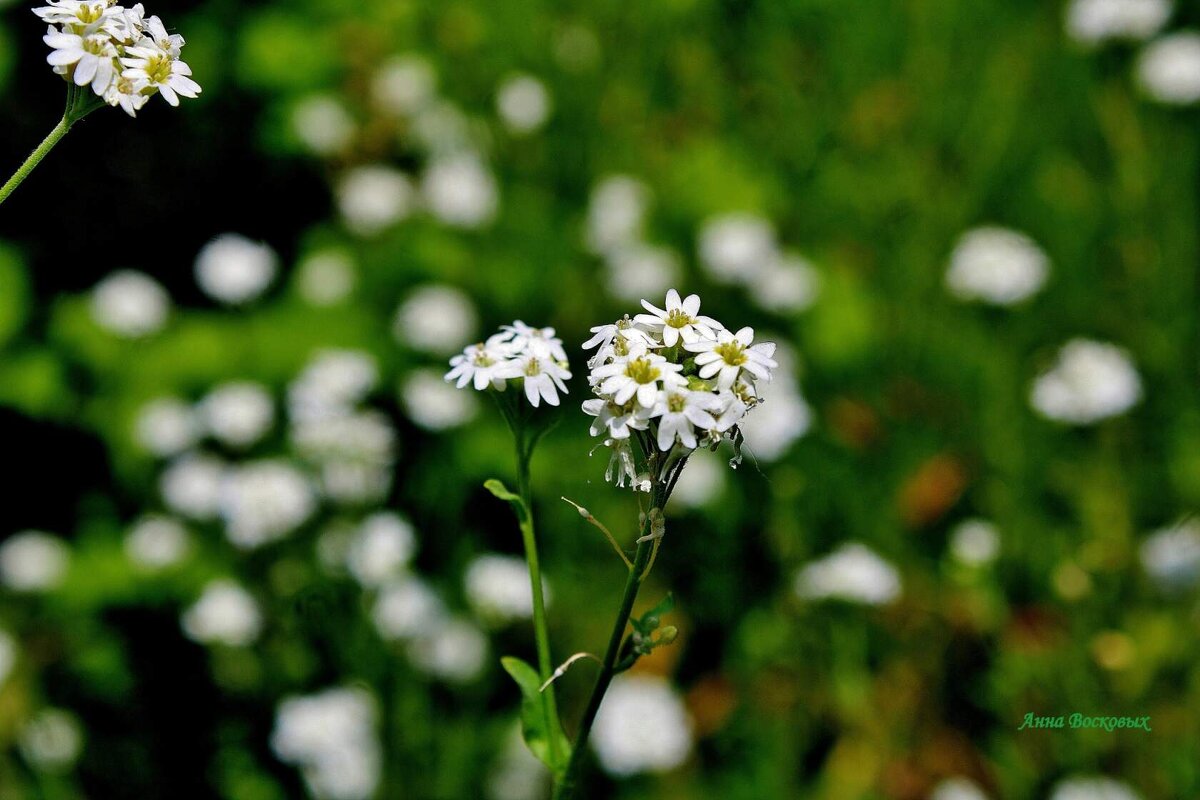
(1030, 339, 1141, 425)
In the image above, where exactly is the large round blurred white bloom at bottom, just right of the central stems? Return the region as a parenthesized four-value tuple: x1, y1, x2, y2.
(592, 674, 692, 777)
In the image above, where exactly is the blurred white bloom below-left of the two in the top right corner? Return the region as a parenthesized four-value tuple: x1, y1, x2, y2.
(946, 228, 1050, 306)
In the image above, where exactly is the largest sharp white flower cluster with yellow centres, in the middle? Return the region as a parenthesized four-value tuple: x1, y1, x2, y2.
(583, 289, 779, 491)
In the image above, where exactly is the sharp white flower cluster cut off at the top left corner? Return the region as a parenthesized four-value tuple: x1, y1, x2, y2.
(34, 0, 200, 116)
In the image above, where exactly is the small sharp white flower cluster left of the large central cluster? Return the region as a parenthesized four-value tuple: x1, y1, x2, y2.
(445, 320, 571, 408)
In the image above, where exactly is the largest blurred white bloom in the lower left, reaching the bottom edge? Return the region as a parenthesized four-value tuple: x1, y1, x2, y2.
(271, 688, 383, 800)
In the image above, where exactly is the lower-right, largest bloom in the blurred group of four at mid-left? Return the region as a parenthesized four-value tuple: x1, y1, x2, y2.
(220, 461, 317, 549)
